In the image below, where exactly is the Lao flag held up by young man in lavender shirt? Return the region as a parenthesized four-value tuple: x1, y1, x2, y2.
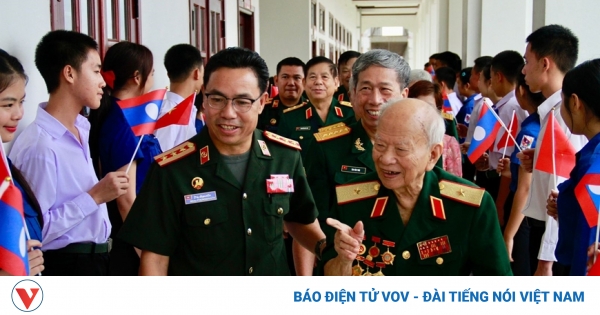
(117, 89, 167, 136)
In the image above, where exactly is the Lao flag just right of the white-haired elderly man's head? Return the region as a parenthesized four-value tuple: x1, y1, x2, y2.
(467, 104, 502, 164)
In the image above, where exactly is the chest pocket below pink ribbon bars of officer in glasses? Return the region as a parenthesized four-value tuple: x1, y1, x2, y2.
(264, 194, 290, 243)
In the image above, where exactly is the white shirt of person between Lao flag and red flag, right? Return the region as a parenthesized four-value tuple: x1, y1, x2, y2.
(489, 90, 529, 170)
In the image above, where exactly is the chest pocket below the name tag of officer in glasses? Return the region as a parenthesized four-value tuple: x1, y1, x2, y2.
(183, 201, 230, 252)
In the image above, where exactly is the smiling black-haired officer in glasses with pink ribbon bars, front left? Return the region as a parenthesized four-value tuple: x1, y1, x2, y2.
(119, 48, 324, 275)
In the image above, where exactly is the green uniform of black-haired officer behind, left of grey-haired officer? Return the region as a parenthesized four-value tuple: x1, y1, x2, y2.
(279, 98, 354, 157)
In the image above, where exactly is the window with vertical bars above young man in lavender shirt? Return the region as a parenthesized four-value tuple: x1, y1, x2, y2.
(50, 0, 141, 54)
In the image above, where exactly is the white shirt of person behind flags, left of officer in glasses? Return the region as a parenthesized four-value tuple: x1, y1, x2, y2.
(154, 91, 198, 152)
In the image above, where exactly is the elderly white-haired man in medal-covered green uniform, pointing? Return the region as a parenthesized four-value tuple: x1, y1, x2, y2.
(323, 99, 512, 276)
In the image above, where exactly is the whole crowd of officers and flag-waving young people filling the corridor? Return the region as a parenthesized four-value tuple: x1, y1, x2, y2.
(0, 25, 600, 276)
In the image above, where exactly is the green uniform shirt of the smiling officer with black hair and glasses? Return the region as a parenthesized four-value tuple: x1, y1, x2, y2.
(114, 128, 317, 275)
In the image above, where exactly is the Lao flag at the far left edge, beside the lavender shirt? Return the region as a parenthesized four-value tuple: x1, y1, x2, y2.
(0, 155, 29, 276)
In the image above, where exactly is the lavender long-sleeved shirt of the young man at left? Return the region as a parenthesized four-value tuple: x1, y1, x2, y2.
(9, 103, 111, 250)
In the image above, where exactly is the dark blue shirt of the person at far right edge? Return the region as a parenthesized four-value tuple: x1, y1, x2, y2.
(555, 134, 600, 276)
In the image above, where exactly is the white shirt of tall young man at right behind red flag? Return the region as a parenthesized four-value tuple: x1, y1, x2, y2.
(523, 90, 588, 261)
